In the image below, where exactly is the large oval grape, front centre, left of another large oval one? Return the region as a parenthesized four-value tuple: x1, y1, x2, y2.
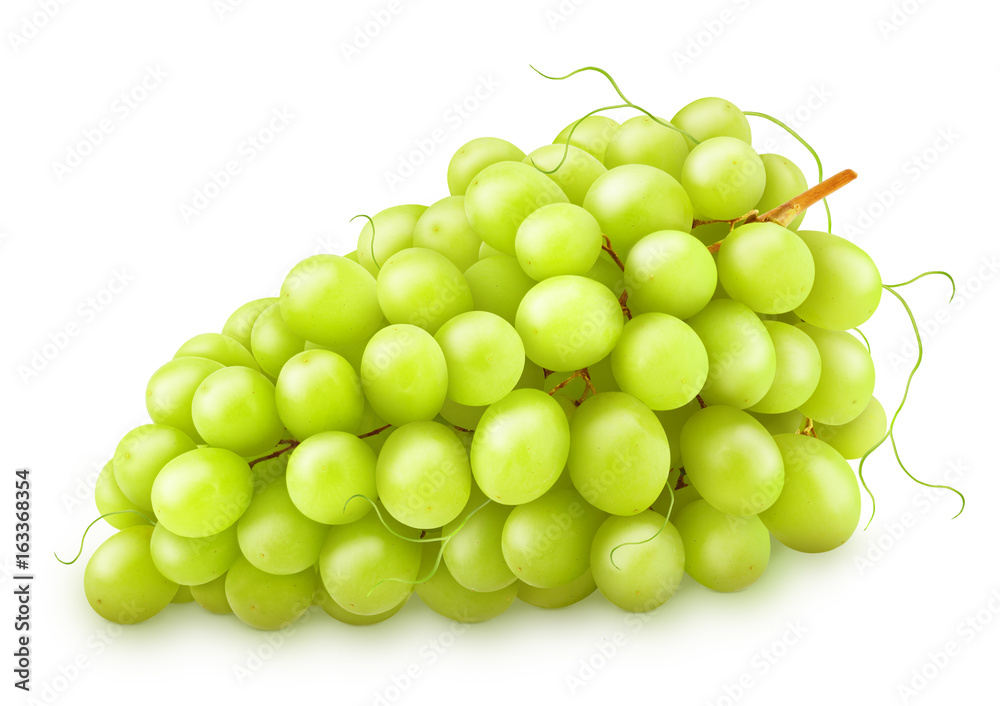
(470, 389, 570, 505)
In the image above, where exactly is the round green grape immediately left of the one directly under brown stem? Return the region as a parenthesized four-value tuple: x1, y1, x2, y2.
(625, 230, 717, 319)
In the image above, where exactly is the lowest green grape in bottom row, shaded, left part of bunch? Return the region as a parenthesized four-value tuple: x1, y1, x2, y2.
(226, 557, 316, 630)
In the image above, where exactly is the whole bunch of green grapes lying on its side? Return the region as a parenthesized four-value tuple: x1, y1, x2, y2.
(84, 93, 886, 629)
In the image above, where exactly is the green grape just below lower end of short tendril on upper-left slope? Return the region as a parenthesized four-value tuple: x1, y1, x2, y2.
(376, 248, 472, 335)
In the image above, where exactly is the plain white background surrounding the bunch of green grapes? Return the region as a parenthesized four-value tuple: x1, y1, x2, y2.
(0, 0, 1000, 704)
